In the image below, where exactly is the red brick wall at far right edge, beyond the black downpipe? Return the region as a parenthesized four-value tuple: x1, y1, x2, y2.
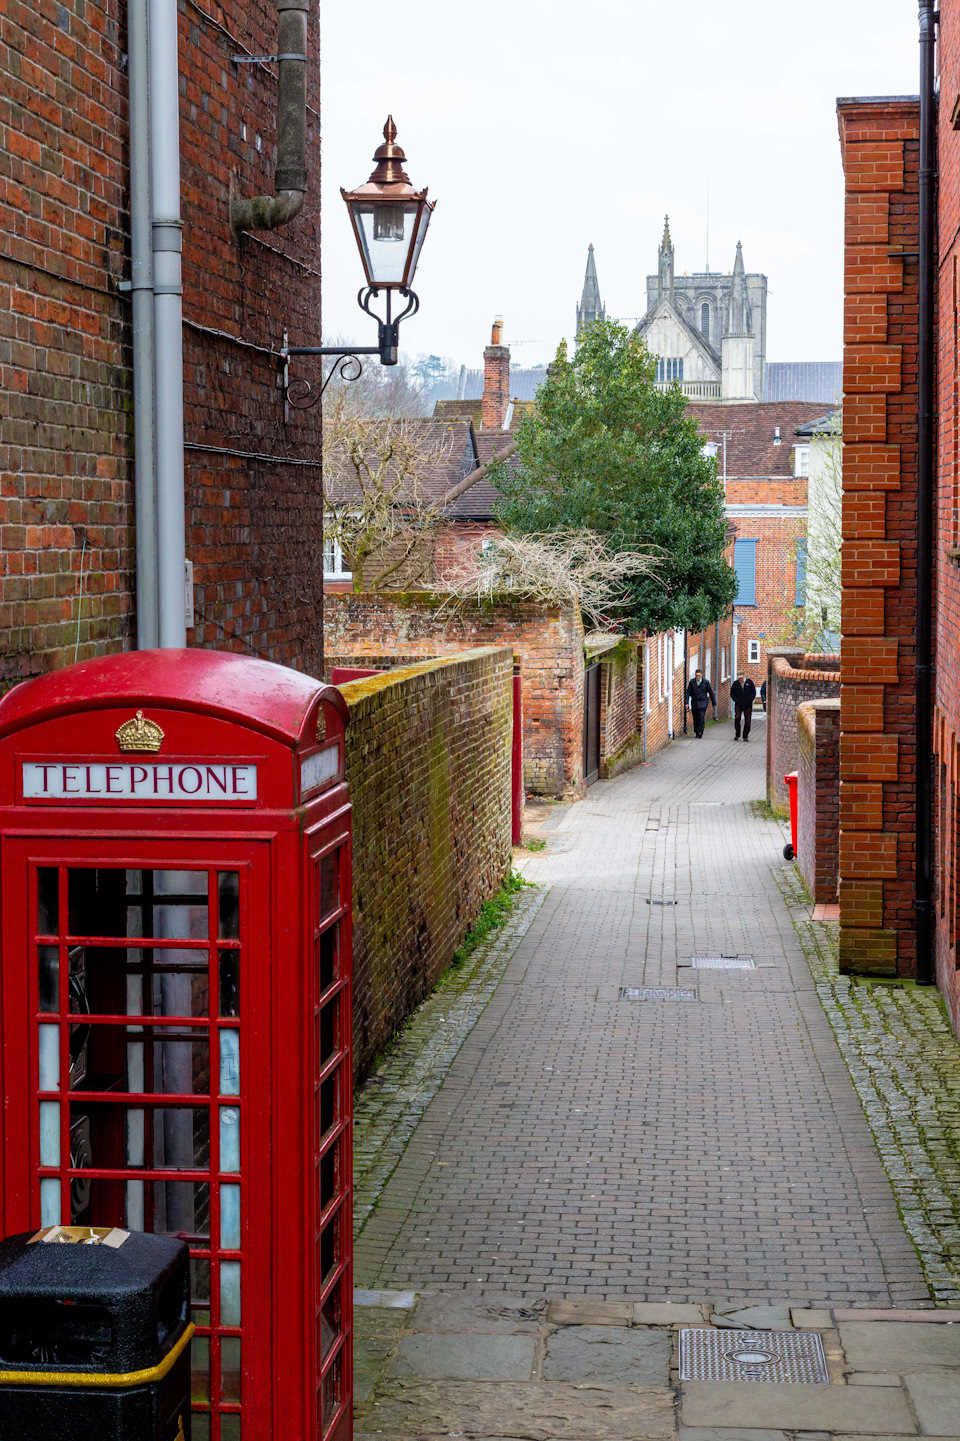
(934, 0, 960, 1032)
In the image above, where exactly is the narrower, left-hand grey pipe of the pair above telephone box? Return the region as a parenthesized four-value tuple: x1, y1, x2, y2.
(127, 0, 160, 650)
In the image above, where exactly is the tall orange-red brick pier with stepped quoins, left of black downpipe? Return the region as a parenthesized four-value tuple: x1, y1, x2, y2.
(839, 99, 920, 976)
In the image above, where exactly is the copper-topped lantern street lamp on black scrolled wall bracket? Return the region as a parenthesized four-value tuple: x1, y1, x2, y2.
(280, 115, 437, 409)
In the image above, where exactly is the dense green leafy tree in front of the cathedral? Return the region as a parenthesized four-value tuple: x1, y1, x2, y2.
(489, 321, 737, 633)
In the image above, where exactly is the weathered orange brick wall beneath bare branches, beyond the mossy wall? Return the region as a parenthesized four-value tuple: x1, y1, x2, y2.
(324, 591, 584, 797)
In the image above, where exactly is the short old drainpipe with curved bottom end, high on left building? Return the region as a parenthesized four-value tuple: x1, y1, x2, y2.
(231, 0, 310, 233)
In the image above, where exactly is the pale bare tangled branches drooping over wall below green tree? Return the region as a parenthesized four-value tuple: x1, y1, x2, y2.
(444, 530, 660, 628)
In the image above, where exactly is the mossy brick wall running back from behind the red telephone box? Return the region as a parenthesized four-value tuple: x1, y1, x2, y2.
(340, 647, 513, 1078)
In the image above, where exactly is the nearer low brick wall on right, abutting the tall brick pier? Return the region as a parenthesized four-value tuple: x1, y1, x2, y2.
(797, 697, 840, 904)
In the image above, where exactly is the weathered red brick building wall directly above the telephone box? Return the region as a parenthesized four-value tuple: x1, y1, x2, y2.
(0, 0, 321, 686)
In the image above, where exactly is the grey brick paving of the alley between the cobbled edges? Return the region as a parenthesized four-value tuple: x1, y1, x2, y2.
(356, 716, 930, 1307)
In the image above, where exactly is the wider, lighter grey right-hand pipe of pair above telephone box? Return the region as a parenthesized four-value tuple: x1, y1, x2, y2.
(148, 0, 186, 648)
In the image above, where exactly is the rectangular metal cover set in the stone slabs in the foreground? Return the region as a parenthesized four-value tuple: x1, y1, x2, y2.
(680, 1329, 830, 1386)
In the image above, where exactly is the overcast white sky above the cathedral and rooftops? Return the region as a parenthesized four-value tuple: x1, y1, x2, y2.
(320, 0, 917, 377)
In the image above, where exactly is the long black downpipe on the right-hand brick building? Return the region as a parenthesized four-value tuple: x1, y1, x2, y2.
(914, 0, 937, 986)
